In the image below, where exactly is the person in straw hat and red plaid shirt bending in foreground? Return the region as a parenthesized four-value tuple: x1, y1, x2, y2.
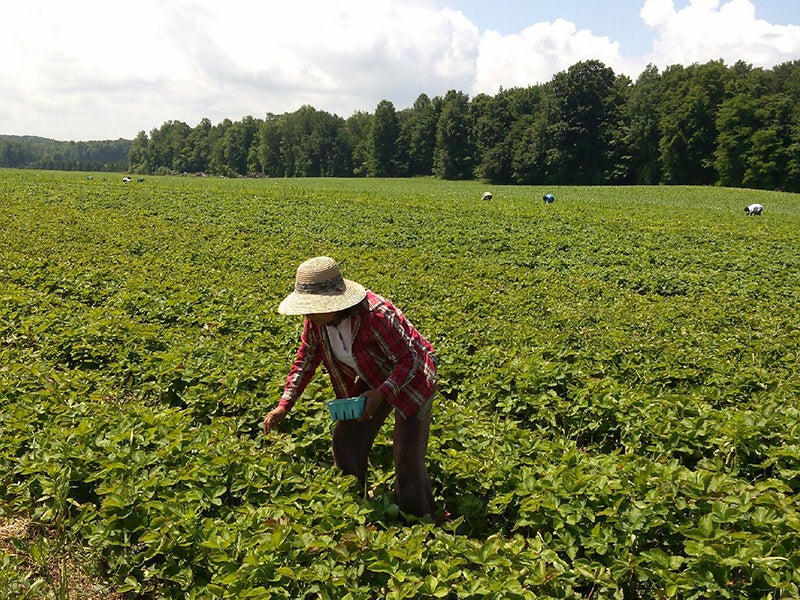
(264, 256, 436, 516)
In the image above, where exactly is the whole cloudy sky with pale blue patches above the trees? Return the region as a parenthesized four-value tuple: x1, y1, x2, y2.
(0, 0, 800, 140)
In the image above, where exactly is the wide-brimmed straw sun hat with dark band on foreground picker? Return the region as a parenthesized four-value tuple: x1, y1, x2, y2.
(278, 256, 367, 315)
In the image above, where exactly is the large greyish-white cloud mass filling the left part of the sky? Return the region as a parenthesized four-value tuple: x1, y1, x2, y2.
(0, 0, 479, 139)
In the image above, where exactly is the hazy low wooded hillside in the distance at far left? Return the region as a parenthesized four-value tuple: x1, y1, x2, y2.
(0, 134, 131, 171)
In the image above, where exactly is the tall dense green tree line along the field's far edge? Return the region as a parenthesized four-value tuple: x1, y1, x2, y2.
(0, 60, 800, 191)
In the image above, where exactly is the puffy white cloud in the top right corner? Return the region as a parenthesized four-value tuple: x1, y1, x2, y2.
(640, 0, 800, 67)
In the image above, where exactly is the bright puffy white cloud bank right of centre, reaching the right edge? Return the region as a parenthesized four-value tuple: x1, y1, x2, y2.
(473, 0, 800, 94)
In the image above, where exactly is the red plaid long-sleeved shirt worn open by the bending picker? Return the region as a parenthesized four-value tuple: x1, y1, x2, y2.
(279, 291, 436, 417)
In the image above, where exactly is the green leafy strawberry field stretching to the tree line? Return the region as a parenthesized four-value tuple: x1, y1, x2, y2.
(0, 170, 800, 599)
